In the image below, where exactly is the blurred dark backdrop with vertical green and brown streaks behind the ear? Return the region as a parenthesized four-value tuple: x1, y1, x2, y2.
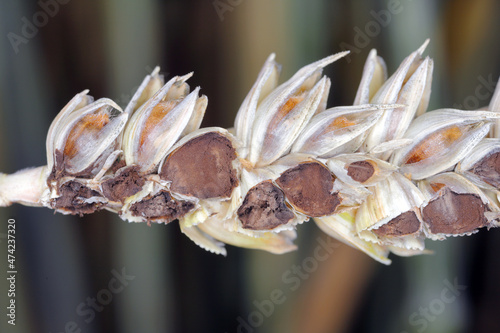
(0, 0, 500, 333)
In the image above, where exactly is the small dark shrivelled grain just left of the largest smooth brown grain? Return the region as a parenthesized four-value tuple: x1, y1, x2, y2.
(102, 166, 146, 202)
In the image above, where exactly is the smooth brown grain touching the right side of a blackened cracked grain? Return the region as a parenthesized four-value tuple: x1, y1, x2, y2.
(276, 162, 341, 217)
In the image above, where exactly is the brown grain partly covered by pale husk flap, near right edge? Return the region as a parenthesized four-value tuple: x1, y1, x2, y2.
(422, 187, 488, 235)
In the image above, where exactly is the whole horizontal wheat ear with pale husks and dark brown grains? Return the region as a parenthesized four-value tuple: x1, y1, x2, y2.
(0, 40, 500, 264)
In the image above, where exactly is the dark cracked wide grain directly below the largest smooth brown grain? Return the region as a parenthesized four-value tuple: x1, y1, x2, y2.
(130, 191, 194, 223)
